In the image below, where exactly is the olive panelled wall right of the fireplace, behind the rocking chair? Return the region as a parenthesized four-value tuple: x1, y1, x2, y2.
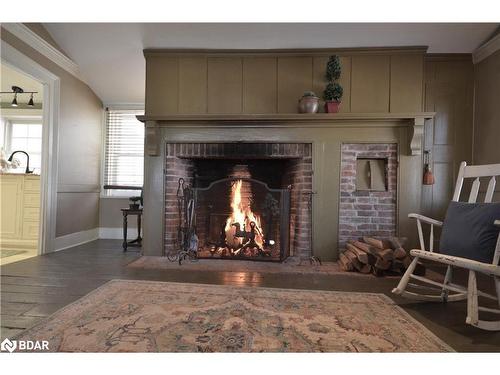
(422, 55, 474, 219)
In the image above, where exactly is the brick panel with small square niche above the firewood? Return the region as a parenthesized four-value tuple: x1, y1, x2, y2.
(339, 143, 398, 248)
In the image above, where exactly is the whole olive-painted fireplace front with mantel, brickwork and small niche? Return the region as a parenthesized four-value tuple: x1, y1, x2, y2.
(140, 113, 432, 261)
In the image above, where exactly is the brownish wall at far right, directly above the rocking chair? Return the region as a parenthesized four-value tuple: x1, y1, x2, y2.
(473, 50, 500, 202)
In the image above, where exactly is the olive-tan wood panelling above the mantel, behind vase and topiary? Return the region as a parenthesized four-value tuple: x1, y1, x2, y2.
(145, 49, 425, 116)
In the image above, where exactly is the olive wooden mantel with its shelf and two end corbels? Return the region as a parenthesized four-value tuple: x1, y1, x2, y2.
(137, 112, 435, 156)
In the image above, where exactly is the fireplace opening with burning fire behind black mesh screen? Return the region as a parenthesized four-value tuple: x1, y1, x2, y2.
(193, 159, 291, 261)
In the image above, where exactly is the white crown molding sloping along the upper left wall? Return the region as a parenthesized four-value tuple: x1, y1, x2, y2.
(2, 23, 87, 83)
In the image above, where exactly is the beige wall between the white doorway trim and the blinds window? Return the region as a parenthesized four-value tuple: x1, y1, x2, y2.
(1, 25, 103, 236)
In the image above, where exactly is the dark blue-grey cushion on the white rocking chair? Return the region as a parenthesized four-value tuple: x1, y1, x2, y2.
(439, 202, 500, 264)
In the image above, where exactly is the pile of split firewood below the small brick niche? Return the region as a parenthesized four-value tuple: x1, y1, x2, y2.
(339, 237, 425, 276)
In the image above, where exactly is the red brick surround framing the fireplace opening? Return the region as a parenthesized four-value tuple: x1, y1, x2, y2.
(164, 143, 313, 258)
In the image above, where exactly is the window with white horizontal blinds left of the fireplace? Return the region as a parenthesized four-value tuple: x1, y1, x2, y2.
(104, 110, 144, 197)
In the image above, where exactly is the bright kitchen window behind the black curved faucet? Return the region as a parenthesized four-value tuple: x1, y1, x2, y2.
(5, 119, 42, 174)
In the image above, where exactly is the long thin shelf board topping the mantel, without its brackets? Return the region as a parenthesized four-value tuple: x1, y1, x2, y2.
(137, 112, 435, 126)
